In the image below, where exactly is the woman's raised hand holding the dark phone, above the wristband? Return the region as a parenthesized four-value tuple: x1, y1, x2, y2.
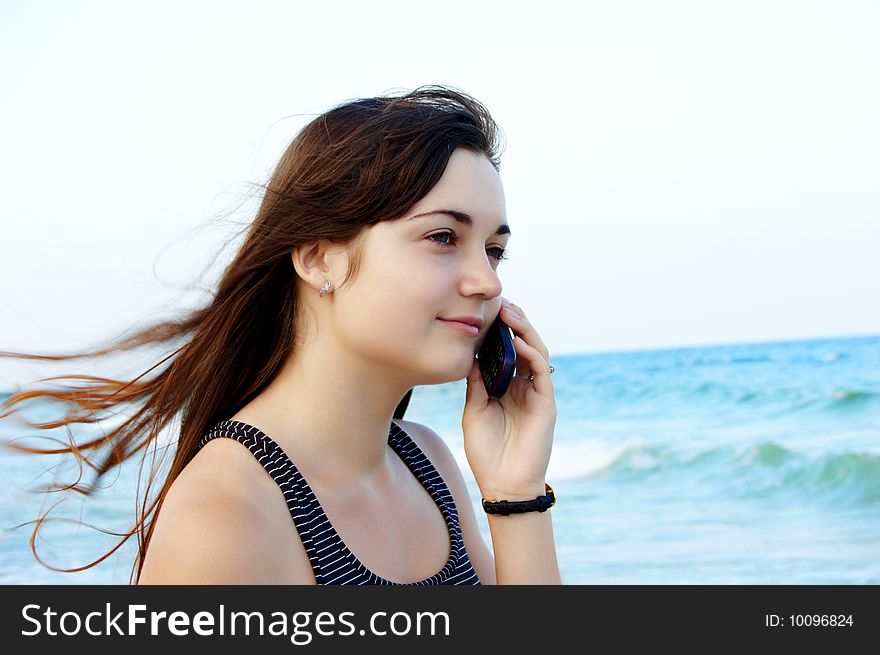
(461, 298, 556, 500)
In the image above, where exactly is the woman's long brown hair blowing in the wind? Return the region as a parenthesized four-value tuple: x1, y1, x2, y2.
(0, 85, 501, 582)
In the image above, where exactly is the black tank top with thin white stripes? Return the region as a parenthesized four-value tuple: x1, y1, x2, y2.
(198, 421, 480, 586)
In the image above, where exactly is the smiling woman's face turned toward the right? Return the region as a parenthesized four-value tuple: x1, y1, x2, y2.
(334, 148, 510, 384)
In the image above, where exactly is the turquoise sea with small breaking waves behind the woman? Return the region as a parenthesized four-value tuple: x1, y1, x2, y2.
(0, 335, 880, 585)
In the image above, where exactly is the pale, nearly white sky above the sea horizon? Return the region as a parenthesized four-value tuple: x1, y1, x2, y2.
(0, 0, 880, 389)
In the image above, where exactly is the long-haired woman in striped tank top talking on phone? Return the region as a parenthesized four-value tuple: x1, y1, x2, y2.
(1, 86, 560, 584)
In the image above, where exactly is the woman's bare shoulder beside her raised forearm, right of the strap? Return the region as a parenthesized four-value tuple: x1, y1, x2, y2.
(394, 419, 496, 584)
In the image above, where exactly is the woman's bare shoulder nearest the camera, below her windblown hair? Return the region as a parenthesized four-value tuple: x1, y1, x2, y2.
(138, 438, 315, 584)
